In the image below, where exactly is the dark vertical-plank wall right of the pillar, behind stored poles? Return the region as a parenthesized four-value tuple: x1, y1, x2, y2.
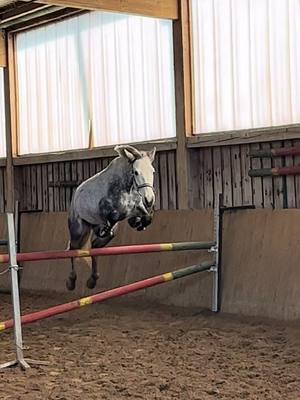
(189, 140, 300, 209)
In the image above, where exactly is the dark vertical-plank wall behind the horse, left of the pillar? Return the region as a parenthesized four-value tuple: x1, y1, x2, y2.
(14, 151, 177, 211)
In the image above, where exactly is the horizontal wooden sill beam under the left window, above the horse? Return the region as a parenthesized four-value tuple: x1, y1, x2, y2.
(13, 139, 177, 166)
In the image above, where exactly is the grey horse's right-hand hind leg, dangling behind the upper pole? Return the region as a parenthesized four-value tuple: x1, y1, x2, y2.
(86, 224, 117, 289)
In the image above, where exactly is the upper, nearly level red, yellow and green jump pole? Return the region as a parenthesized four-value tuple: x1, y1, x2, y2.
(0, 242, 215, 264)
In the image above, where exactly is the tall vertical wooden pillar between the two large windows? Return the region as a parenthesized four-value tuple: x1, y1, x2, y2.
(173, 0, 188, 210)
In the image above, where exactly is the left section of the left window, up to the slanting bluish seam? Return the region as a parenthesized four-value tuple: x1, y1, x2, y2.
(16, 21, 89, 154)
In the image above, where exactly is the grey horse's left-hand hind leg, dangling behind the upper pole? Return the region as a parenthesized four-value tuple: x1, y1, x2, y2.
(66, 218, 91, 290)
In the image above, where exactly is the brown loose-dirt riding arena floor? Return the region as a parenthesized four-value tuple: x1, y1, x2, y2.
(0, 294, 300, 400)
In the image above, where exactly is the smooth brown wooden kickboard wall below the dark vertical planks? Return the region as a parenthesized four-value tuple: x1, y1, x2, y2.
(0, 209, 300, 321)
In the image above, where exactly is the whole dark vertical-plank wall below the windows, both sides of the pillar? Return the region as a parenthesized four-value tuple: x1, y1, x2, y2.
(7, 139, 300, 211)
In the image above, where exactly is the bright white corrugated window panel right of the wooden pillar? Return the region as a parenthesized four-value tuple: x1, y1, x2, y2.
(190, 0, 300, 133)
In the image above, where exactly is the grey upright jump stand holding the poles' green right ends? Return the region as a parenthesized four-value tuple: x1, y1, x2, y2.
(211, 194, 221, 312)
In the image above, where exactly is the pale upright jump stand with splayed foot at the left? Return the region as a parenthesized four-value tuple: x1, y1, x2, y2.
(0, 213, 29, 369)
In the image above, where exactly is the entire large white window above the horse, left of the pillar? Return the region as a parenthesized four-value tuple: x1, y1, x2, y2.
(16, 12, 176, 154)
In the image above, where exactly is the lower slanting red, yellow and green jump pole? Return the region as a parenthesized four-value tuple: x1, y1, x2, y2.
(0, 261, 214, 331)
